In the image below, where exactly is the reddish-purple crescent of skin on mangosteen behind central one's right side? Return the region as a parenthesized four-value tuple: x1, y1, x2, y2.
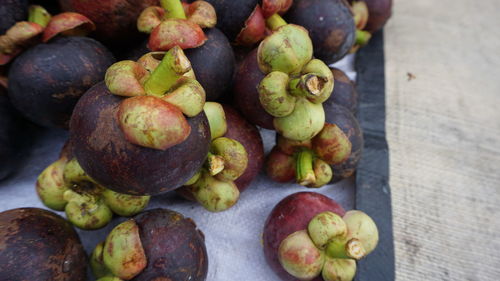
(224, 105, 264, 192)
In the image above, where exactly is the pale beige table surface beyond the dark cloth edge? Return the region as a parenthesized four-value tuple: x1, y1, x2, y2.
(384, 0, 500, 281)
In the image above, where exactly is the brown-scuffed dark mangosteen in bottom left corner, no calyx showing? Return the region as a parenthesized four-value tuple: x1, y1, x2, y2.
(0, 208, 87, 281)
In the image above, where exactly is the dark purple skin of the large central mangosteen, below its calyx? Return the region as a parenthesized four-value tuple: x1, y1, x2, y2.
(70, 83, 210, 195)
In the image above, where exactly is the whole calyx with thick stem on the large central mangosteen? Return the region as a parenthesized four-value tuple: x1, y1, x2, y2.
(105, 46, 206, 150)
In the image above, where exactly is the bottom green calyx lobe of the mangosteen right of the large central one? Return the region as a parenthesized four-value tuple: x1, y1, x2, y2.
(273, 98, 325, 141)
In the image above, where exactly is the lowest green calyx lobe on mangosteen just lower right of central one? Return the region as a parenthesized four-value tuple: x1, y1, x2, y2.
(186, 170, 240, 212)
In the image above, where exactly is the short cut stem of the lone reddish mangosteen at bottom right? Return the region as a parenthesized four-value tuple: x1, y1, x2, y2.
(325, 238, 366, 260)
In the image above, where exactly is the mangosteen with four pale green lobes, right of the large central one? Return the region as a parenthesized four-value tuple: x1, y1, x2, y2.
(235, 21, 333, 141)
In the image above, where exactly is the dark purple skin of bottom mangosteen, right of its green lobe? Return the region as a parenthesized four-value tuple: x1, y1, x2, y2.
(132, 209, 208, 281)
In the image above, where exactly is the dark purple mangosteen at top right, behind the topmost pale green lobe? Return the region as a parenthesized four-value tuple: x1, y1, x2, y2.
(285, 0, 356, 64)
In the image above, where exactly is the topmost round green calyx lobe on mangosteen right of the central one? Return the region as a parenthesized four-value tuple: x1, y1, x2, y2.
(257, 24, 313, 74)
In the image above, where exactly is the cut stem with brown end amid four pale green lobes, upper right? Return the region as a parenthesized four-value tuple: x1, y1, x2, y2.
(288, 73, 327, 97)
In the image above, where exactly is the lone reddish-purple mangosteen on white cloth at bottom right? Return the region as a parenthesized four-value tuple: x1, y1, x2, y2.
(263, 192, 378, 281)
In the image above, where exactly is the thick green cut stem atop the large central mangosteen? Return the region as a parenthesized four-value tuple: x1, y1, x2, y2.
(144, 46, 191, 97)
